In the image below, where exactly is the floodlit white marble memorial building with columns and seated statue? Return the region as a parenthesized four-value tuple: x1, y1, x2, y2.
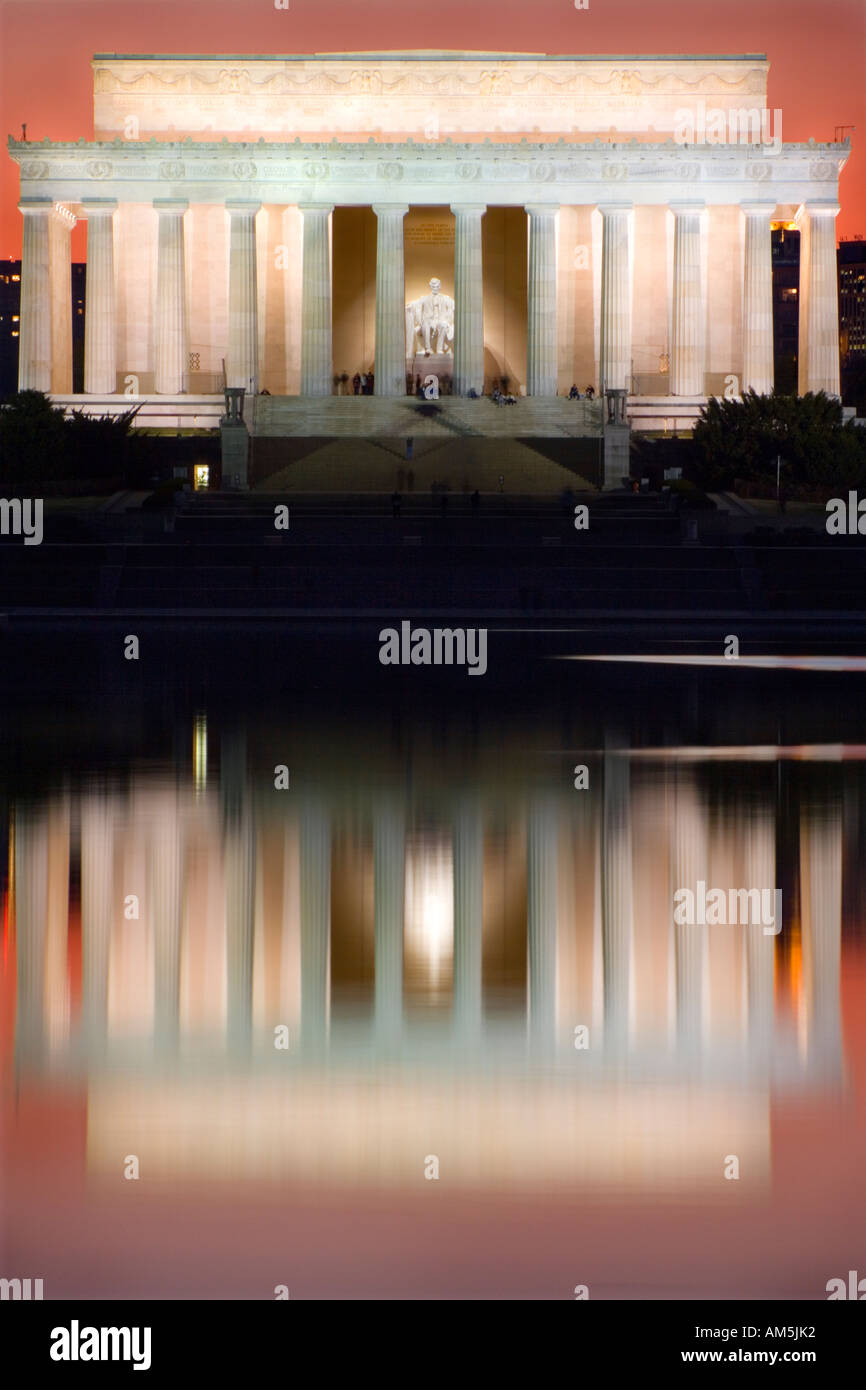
(8, 51, 848, 425)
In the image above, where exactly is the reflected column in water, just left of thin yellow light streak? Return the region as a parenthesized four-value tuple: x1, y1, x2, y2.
(149, 805, 183, 1051)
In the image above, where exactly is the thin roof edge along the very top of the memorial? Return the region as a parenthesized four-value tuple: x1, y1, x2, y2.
(92, 49, 767, 63)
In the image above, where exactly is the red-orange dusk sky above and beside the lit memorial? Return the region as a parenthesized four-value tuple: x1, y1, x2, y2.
(0, 0, 866, 257)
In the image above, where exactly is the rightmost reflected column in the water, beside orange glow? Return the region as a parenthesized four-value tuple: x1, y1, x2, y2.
(799, 788, 842, 1070)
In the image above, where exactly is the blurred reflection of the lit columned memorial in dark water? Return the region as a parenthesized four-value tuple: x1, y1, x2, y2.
(6, 739, 842, 1183)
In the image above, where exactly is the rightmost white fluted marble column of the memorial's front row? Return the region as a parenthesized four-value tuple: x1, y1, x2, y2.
(796, 203, 840, 396)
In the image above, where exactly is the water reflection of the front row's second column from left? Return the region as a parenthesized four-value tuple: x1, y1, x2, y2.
(81, 796, 114, 1051)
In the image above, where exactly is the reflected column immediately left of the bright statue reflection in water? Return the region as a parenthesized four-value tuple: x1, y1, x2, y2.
(373, 799, 406, 1036)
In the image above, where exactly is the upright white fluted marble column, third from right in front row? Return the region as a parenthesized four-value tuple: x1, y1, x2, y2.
(670, 203, 706, 396)
